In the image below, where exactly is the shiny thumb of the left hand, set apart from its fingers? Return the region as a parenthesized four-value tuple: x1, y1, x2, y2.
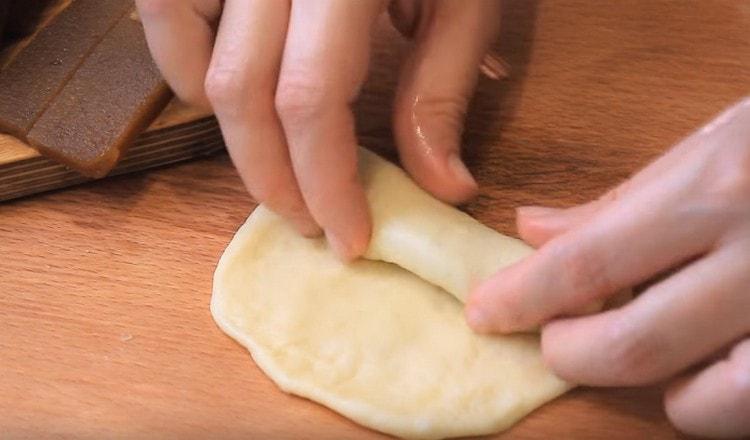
(394, 0, 499, 203)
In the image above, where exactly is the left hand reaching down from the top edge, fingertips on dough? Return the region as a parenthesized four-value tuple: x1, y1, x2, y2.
(137, 0, 499, 258)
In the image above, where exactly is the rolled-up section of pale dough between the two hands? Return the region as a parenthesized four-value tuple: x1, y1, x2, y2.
(359, 149, 531, 302)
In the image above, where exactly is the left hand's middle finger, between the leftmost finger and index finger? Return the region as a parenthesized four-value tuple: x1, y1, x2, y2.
(206, 0, 320, 235)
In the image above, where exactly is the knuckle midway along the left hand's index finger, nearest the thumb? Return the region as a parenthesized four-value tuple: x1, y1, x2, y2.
(274, 71, 331, 123)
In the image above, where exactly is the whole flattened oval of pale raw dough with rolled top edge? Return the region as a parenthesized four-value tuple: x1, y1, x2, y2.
(211, 151, 570, 439)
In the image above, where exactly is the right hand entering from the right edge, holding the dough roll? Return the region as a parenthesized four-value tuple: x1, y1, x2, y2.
(466, 99, 750, 436)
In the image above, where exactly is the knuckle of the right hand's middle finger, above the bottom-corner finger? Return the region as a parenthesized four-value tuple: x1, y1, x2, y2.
(601, 318, 663, 385)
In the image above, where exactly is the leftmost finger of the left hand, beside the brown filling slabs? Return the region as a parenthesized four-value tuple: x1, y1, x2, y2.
(136, 0, 221, 109)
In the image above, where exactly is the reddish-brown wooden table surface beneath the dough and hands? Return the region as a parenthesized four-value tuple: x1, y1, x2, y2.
(0, 0, 750, 439)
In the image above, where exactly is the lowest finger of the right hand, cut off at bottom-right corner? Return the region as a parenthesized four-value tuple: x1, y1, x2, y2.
(665, 339, 750, 438)
